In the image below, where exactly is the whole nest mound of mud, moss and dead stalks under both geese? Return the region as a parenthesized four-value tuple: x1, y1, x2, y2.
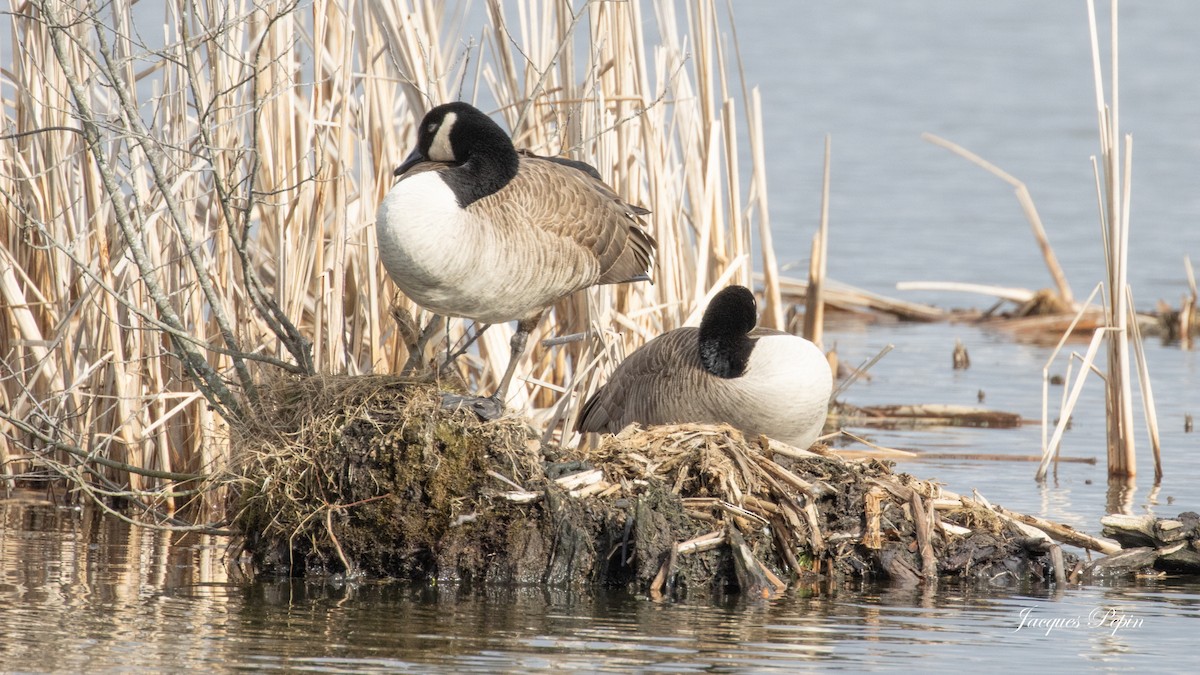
(232, 376, 1094, 595)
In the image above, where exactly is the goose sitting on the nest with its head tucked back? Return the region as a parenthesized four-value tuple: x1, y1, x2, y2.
(576, 286, 833, 448)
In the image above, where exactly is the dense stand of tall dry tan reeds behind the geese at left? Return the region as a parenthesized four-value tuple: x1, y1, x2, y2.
(0, 0, 780, 513)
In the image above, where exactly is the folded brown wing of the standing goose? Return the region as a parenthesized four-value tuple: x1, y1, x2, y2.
(505, 153, 656, 283)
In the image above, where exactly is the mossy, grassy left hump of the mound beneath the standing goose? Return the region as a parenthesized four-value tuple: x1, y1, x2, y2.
(232, 376, 542, 574)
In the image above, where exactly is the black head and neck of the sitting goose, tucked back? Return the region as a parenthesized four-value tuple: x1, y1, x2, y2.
(698, 286, 758, 378)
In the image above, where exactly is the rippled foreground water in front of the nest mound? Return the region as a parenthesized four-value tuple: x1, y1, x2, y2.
(0, 502, 1200, 673)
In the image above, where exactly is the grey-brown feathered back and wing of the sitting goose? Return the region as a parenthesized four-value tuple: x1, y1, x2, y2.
(576, 328, 712, 434)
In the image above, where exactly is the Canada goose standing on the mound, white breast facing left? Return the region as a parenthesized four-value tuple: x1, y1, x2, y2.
(376, 102, 655, 417)
